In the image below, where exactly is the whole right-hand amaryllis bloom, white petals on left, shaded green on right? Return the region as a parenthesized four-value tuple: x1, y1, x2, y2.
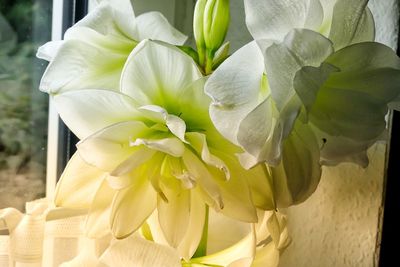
(206, 0, 400, 206)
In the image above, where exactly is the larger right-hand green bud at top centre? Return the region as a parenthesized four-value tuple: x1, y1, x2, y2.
(203, 0, 230, 53)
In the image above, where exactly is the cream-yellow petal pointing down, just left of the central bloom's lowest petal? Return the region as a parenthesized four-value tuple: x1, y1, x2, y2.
(111, 179, 157, 239)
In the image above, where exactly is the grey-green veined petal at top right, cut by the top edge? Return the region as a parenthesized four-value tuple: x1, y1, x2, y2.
(329, 0, 375, 50)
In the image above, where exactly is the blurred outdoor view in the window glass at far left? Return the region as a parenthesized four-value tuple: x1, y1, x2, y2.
(0, 0, 52, 213)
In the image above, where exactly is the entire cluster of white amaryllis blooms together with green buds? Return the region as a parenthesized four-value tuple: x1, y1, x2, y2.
(38, 0, 400, 266)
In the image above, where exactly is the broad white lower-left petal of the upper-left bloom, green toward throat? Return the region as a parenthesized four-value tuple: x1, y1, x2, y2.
(39, 40, 130, 94)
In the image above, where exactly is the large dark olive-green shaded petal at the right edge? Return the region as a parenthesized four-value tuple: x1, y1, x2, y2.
(295, 43, 400, 142)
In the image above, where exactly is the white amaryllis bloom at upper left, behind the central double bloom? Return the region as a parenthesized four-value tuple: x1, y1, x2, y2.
(37, 0, 186, 94)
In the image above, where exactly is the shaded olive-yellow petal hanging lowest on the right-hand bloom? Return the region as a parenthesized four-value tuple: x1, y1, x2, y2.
(271, 120, 321, 208)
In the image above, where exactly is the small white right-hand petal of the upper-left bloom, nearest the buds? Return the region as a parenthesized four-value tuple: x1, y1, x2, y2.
(136, 12, 187, 45)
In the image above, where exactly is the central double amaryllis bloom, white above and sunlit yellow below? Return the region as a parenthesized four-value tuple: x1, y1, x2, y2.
(53, 40, 275, 258)
